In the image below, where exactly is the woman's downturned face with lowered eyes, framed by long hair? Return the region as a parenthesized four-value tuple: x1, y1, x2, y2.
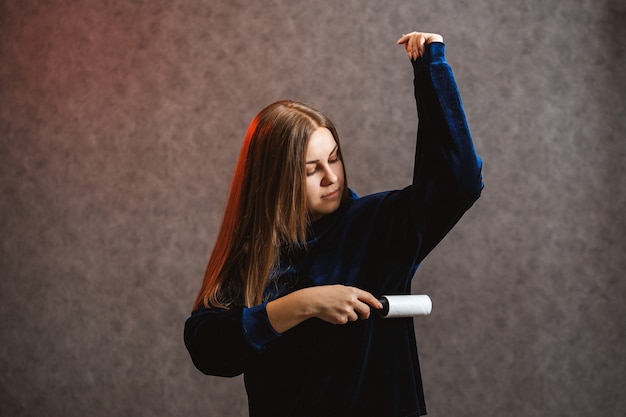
(306, 127, 344, 221)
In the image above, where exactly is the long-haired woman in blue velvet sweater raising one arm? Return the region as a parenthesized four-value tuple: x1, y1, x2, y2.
(185, 32, 482, 417)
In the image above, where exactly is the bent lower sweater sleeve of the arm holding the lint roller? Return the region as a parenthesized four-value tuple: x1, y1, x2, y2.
(184, 304, 280, 377)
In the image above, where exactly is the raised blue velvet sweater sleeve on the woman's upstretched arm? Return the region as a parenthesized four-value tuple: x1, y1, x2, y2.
(405, 42, 483, 262)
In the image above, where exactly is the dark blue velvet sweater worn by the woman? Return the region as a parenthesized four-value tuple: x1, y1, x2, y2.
(184, 43, 482, 417)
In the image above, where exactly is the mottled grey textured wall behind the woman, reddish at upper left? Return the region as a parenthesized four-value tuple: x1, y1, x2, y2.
(0, 0, 626, 417)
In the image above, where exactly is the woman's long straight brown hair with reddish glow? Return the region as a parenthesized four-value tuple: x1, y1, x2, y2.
(193, 101, 348, 310)
